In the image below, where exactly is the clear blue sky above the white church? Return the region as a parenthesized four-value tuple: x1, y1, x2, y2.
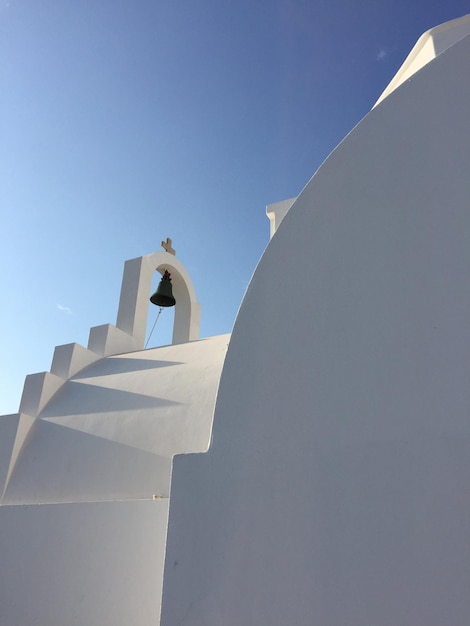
(0, 0, 470, 414)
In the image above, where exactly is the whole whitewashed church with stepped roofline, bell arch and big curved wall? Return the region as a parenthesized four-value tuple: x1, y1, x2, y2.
(0, 16, 470, 626)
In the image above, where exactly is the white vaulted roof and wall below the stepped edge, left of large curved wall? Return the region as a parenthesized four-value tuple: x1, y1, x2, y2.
(0, 335, 229, 626)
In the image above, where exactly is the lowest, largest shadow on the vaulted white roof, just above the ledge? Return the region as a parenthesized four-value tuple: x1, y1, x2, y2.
(4, 420, 172, 504)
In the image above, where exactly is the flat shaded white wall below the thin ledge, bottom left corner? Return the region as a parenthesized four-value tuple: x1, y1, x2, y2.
(0, 500, 168, 626)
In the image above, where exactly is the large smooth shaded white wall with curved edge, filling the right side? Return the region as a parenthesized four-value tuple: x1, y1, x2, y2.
(162, 26, 470, 626)
